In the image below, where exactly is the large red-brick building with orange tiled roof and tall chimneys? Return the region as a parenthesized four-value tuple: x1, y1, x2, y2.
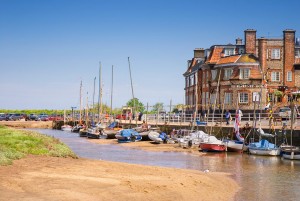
(183, 29, 300, 112)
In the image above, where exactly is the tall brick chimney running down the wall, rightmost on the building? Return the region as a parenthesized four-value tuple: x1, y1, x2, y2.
(283, 29, 296, 87)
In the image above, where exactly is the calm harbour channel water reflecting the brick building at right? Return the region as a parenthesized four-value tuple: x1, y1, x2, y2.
(34, 129, 300, 201)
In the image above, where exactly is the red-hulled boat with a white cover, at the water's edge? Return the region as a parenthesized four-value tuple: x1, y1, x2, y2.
(199, 136, 226, 152)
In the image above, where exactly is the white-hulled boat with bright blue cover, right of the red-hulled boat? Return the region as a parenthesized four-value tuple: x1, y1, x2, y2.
(249, 139, 281, 156)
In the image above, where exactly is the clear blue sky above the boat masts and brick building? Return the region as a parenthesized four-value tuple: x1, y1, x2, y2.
(0, 0, 300, 109)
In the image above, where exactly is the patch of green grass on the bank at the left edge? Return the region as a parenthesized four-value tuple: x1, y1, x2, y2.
(0, 125, 77, 165)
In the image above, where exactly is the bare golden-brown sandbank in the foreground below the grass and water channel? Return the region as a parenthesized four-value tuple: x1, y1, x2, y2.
(0, 155, 239, 201)
